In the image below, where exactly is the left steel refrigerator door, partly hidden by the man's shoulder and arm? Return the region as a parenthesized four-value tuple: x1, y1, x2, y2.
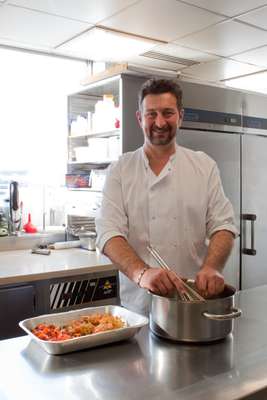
(178, 130, 240, 288)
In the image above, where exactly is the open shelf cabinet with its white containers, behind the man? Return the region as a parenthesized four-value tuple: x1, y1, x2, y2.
(66, 73, 145, 191)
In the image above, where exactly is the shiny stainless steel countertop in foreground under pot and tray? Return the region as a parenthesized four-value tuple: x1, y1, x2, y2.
(0, 286, 267, 400)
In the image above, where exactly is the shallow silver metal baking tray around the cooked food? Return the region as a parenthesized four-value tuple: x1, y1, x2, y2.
(19, 305, 148, 355)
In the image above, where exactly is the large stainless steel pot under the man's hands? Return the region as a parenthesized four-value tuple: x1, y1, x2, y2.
(149, 285, 241, 342)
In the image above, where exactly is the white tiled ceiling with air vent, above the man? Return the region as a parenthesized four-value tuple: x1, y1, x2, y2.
(0, 0, 267, 89)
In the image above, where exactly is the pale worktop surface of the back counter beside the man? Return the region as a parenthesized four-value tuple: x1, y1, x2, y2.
(0, 248, 114, 285)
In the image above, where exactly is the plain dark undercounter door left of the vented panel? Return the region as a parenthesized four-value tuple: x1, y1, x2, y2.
(0, 285, 35, 339)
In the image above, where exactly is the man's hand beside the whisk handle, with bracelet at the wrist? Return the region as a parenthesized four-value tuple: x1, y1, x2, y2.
(140, 268, 184, 296)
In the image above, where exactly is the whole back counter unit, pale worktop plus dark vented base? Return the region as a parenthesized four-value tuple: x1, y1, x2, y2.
(0, 248, 120, 340)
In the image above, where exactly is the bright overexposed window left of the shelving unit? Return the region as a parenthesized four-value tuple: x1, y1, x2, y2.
(0, 49, 87, 227)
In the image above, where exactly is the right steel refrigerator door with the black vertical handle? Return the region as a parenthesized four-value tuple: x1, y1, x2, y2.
(242, 135, 267, 289)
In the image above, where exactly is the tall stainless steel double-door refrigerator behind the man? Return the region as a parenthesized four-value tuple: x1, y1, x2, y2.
(177, 82, 267, 289)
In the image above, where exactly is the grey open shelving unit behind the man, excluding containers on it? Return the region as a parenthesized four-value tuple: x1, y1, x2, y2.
(67, 73, 146, 192)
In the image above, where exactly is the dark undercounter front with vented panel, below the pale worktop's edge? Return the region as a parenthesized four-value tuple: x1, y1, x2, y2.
(0, 270, 119, 340)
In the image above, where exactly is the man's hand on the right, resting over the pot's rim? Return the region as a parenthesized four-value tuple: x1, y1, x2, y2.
(195, 267, 224, 297)
